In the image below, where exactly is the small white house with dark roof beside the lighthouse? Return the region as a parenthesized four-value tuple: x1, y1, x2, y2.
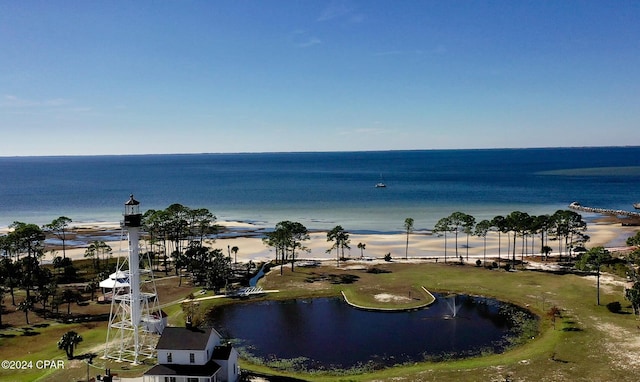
(143, 325, 240, 382)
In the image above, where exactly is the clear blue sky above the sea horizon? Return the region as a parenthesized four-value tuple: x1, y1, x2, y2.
(0, 0, 640, 156)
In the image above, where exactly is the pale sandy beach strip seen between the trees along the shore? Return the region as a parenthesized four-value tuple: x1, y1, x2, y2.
(15, 220, 638, 262)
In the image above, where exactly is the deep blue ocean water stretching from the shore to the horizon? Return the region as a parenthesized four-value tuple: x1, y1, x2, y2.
(0, 147, 640, 232)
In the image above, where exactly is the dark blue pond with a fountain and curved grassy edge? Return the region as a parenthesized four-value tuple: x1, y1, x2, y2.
(208, 295, 536, 370)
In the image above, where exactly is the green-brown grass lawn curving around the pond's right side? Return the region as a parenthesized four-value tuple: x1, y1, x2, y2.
(244, 263, 640, 381)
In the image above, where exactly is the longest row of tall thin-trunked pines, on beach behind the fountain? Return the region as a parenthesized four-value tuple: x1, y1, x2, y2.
(432, 210, 589, 263)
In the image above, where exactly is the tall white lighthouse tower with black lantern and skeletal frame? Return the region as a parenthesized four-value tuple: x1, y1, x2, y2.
(100, 195, 165, 364)
